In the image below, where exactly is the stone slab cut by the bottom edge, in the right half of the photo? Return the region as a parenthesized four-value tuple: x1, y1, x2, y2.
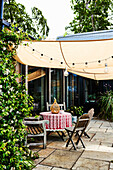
(72, 158, 109, 170)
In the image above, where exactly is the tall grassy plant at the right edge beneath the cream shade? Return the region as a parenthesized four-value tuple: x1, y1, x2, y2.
(99, 85, 113, 121)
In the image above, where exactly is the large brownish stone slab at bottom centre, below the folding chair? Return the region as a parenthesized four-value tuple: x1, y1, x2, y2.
(41, 150, 81, 169)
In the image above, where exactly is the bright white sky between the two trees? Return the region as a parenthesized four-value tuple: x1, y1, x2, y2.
(16, 0, 74, 39)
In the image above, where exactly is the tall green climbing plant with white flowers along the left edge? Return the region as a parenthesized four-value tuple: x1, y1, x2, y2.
(0, 27, 37, 170)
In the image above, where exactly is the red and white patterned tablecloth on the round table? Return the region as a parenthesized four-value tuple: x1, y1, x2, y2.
(40, 112, 72, 131)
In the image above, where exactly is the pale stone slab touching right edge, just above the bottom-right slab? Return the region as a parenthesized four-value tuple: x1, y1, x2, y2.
(81, 151, 113, 161)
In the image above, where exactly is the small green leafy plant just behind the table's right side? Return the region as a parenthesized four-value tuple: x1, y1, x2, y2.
(67, 106, 83, 116)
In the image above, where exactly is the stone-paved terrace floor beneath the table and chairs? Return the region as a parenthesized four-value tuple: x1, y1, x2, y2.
(32, 120, 113, 170)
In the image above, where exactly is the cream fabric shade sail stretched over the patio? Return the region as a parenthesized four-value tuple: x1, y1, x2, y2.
(15, 39, 113, 80)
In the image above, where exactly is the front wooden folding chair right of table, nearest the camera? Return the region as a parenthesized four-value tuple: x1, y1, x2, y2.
(65, 117, 89, 150)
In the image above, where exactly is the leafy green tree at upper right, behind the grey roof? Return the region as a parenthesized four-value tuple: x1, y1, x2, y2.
(66, 0, 113, 33)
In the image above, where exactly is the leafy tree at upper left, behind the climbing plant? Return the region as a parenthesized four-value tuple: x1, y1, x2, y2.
(3, 0, 49, 39)
